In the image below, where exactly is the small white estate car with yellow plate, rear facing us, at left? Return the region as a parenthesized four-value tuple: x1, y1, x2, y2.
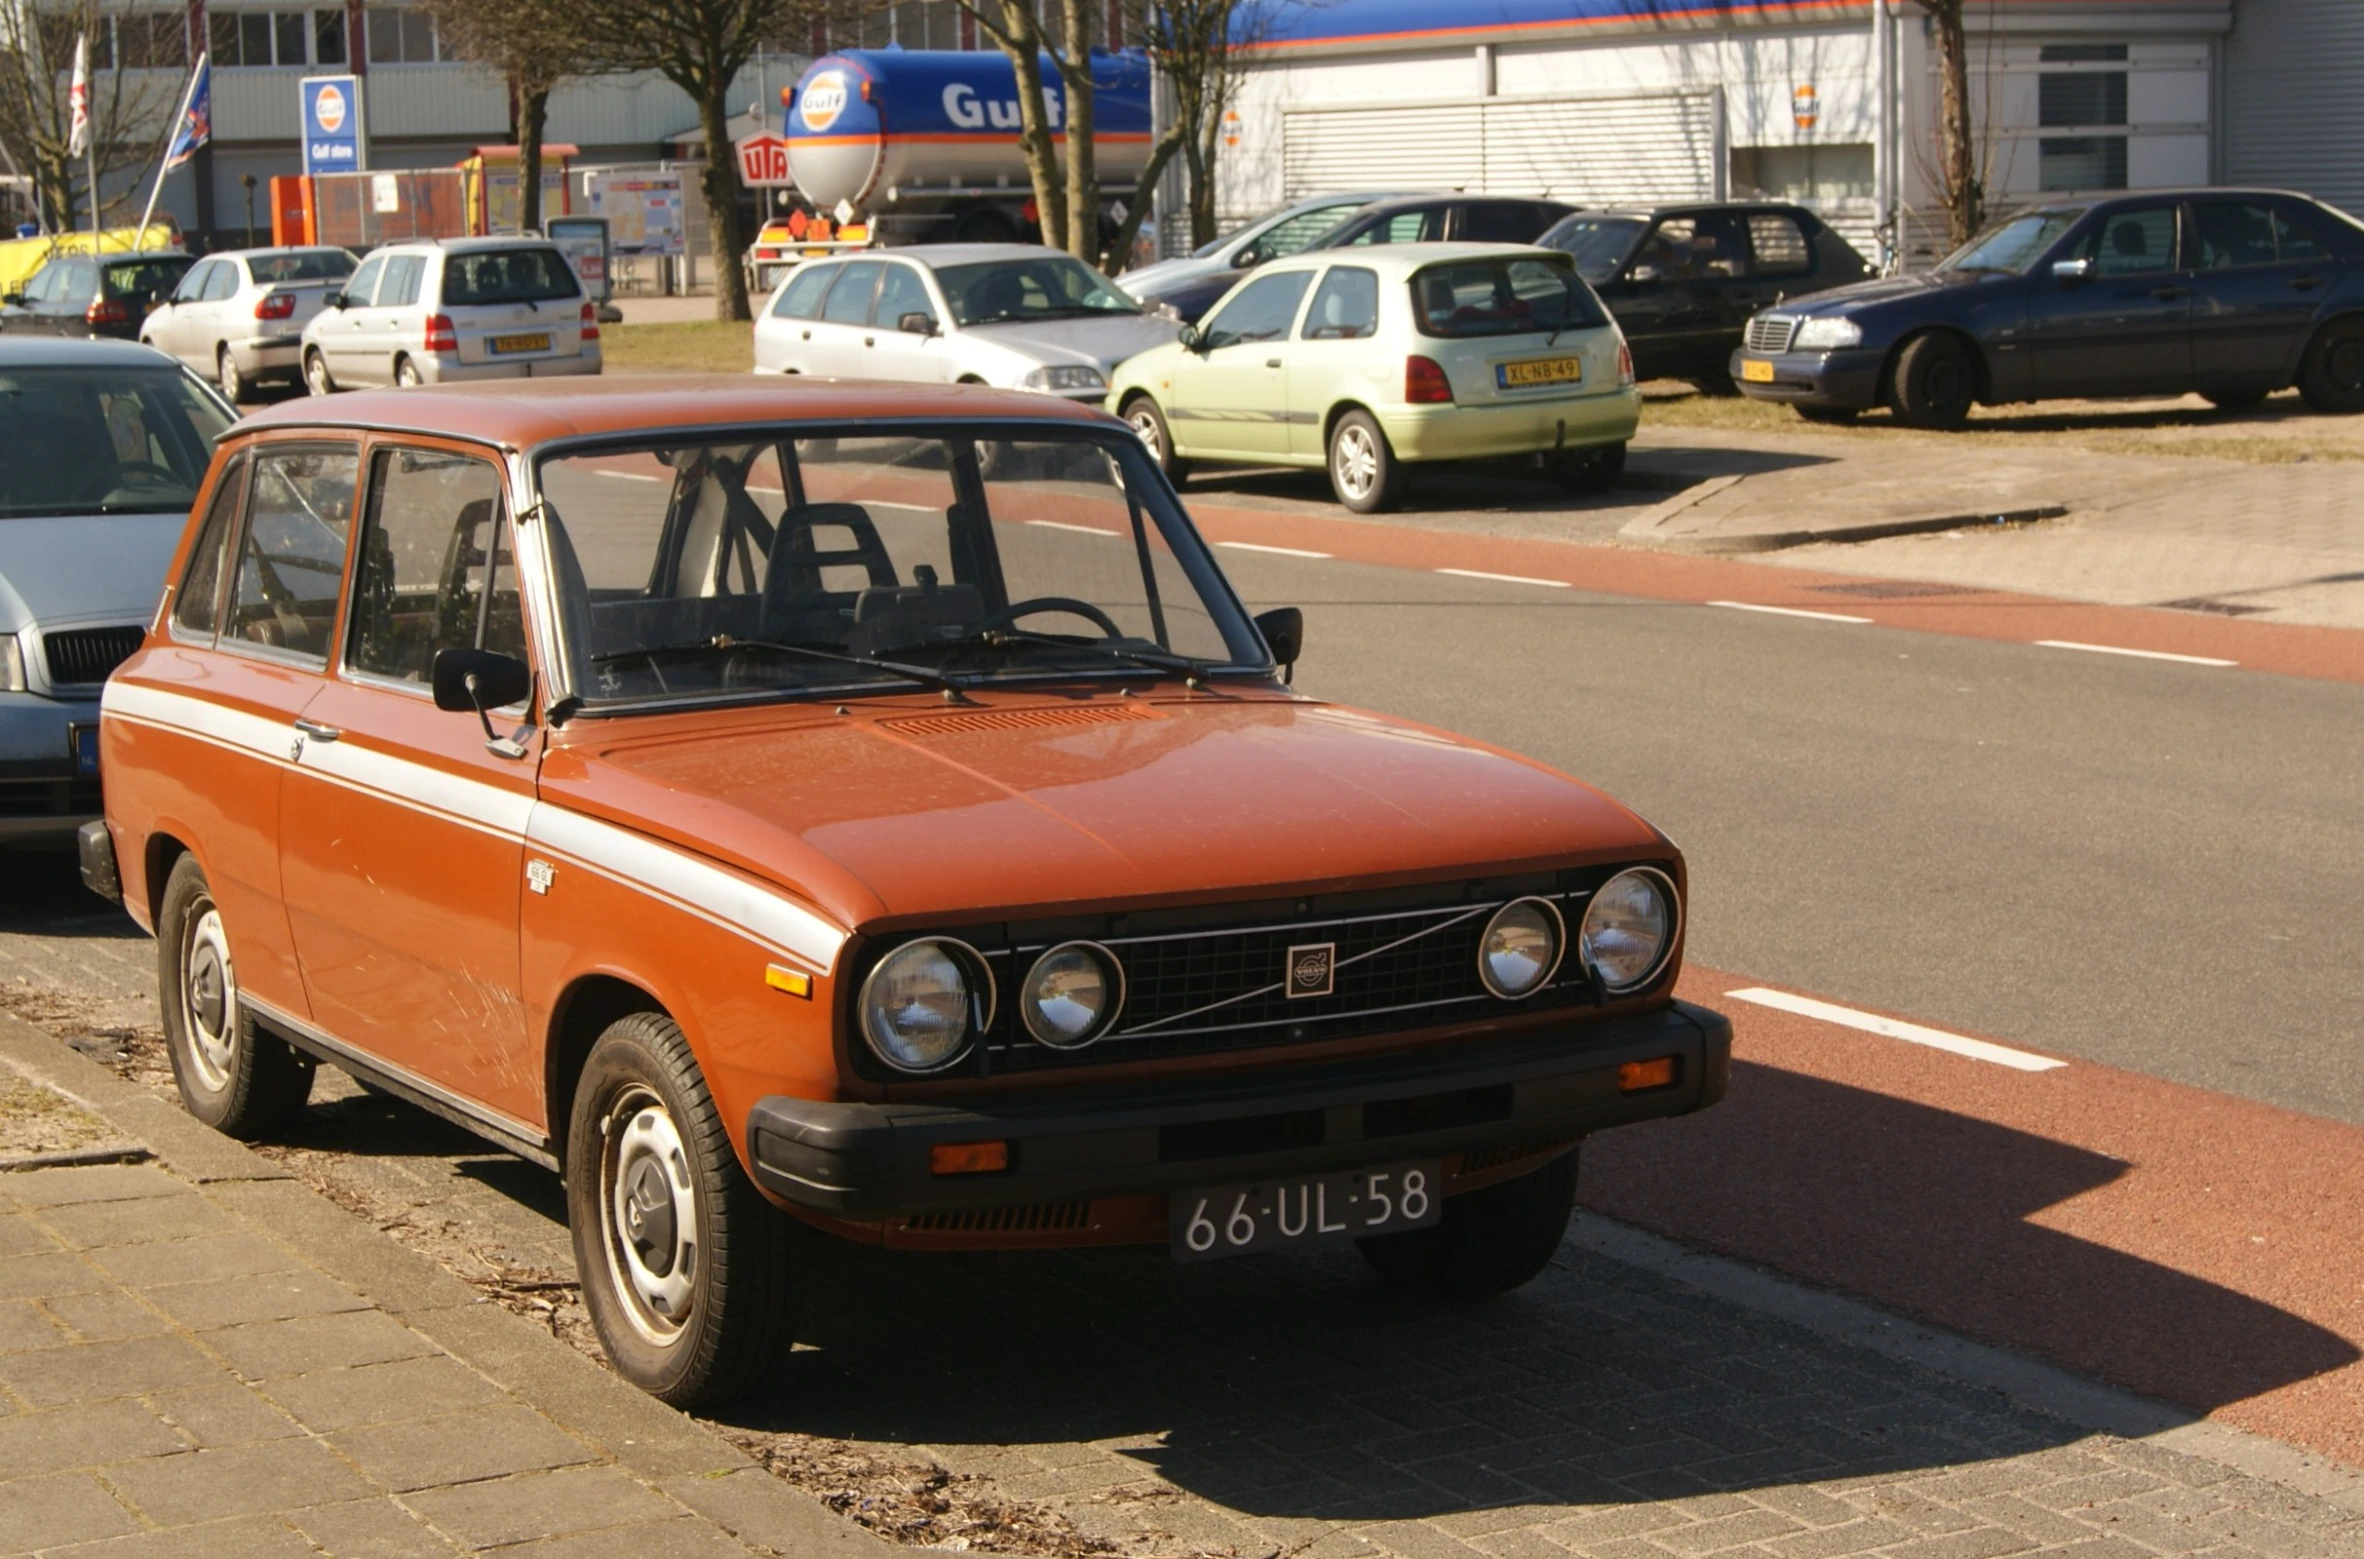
(303, 239, 600, 395)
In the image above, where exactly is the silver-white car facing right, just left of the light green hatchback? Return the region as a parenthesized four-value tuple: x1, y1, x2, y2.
(754, 244, 1182, 402)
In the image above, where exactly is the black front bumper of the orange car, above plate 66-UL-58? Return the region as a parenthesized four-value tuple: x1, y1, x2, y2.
(747, 1001, 1733, 1221)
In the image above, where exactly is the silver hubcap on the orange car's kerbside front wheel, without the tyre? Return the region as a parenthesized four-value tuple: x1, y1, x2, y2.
(600, 1088, 697, 1346)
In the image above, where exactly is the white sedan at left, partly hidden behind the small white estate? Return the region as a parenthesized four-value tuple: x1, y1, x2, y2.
(139, 246, 357, 402)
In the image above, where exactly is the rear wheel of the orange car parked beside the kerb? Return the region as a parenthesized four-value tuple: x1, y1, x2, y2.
(156, 854, 312, 1140)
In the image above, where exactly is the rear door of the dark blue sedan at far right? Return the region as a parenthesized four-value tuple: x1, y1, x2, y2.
(2184, 194, 2340, 390)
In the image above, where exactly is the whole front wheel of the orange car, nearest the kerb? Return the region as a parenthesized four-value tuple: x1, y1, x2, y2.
(565, 1013, 820, 1408)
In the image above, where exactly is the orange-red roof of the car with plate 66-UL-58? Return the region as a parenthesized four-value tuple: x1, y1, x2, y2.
(230, 376, 1113, 449)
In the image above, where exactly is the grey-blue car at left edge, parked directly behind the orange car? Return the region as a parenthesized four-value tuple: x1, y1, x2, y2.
(0, 336, 236, 845)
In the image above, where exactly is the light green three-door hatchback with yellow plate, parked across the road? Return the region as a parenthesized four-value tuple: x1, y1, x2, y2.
(1109, 244, 1641, 513)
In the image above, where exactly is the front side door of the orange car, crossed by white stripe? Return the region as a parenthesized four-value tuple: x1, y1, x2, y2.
(279, 440, 541, 1116)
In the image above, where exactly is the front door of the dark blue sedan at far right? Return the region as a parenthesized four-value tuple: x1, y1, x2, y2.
(2026, 201, 2191, 395)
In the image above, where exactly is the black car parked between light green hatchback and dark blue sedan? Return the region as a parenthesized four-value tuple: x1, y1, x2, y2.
(1537, 201, 1872, 393)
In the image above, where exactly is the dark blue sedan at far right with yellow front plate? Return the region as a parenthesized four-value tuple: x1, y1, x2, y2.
(1733, 189, 2364, 428)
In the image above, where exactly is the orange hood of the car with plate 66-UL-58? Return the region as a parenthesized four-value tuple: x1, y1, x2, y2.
(541, 693, 1674, 927)
